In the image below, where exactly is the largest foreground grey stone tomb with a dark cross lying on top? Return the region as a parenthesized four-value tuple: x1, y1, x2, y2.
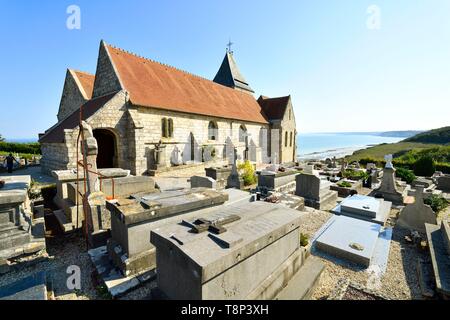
(151, 202, 300, 299)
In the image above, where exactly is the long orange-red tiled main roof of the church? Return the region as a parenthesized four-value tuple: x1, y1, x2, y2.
(106, 45, 267, 123)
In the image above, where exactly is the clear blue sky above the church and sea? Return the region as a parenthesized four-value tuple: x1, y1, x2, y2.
(0, 0, 450, 138)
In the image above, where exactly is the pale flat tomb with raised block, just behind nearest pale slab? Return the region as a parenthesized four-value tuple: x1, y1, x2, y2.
(331, 194, 392, 225)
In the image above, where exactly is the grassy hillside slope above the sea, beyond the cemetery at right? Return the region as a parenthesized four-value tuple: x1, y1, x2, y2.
(346, 142, 440, 162)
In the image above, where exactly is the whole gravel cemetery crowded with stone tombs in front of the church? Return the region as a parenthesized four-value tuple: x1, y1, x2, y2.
(0, 132, 450, 300)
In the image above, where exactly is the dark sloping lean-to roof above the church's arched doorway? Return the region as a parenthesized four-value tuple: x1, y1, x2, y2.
(39, 92, 117, 143)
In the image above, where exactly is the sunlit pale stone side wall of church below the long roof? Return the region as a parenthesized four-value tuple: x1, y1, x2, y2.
(132, 108, 268, 174)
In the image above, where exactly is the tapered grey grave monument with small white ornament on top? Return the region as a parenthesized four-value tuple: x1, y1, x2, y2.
(370, 154, 404, 205)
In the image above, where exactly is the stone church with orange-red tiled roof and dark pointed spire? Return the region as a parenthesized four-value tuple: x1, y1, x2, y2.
(39, 41, 296, 175)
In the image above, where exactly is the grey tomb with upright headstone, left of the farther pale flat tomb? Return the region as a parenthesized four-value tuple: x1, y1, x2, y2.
(295, 173, 338, 210)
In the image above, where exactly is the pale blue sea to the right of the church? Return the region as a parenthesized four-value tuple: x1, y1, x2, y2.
(297, 133, 405, 160)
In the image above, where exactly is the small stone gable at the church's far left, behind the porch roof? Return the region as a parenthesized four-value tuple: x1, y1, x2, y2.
(57, 70, 87, 121)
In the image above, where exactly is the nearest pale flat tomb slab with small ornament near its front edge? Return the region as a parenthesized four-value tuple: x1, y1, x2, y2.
(315, 216, 381, 267)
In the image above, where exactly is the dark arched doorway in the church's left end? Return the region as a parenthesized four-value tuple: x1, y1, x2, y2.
(93, 129, 117, 169)
